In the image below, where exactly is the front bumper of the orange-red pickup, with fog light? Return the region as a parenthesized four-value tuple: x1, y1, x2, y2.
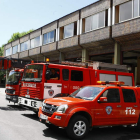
(38, 107, 68, 128)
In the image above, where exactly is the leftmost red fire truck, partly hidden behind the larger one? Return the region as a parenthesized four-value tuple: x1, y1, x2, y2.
(5, 69, 24, 103)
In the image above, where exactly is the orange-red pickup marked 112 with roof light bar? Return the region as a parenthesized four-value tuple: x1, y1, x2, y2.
(38, 81, 140, 139)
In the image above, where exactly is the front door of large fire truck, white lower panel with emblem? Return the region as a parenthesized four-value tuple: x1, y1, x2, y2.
(44, 66, 62, 99)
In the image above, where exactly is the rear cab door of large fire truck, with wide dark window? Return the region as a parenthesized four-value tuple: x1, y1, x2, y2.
(69, 68, 86, 94)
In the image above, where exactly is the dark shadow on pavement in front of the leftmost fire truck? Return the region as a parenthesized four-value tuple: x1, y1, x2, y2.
(0, 105, 27, 111)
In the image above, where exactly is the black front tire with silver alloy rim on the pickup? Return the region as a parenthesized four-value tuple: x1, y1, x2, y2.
(66, 115, 89, 139)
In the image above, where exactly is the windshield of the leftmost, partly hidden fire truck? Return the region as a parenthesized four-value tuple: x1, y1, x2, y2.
(7, 71, 20, 85)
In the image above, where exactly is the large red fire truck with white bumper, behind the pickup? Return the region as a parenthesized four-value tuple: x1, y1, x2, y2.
(19, 62, 134, 111)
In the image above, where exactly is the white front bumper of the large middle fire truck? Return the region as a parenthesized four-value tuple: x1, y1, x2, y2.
(18, 97, 42, 109)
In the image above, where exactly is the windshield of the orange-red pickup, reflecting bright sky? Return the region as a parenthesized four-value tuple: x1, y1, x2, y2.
(70, 87, 104, 100)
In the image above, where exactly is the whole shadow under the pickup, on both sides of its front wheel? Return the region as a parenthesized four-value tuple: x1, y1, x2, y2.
(43, 127, 140, 140)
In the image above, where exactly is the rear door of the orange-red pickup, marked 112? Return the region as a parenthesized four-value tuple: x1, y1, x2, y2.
(122, 87, 139, 124)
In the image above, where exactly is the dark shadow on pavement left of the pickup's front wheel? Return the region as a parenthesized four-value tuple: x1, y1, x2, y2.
(43, 126, 70, 140)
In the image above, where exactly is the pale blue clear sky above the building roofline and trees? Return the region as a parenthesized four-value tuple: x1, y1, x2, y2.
(0, 0, 97, 47)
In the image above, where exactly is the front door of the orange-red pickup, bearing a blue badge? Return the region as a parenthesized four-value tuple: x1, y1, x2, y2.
(94, 88, 122, 125)
